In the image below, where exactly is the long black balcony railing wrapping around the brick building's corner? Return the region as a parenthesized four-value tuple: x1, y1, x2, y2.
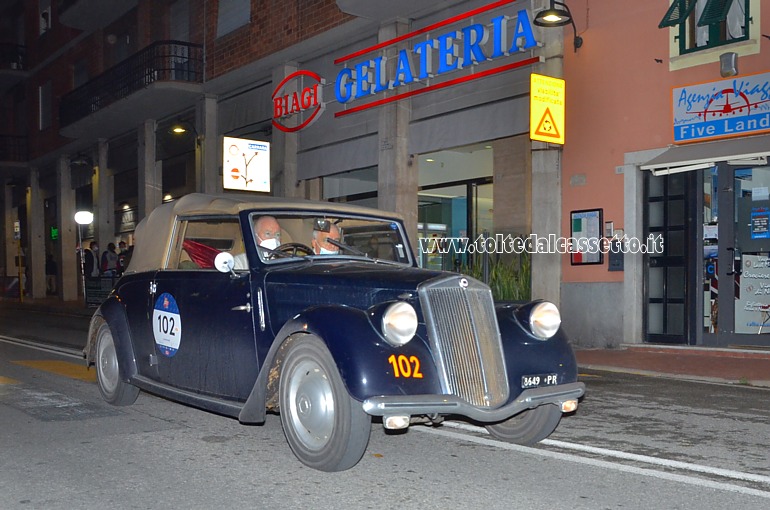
(59, 41, 203, 126)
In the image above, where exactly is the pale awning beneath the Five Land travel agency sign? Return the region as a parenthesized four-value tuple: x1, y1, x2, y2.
(640, 135, 770, 175)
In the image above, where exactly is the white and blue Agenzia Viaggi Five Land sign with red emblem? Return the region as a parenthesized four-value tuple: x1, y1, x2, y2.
(672, 73, 770, 143)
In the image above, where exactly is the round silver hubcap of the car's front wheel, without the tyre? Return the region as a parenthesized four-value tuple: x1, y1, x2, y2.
(288, 360, 334, 450)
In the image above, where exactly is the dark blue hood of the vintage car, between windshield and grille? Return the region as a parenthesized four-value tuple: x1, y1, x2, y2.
(264, 261, 449, 324)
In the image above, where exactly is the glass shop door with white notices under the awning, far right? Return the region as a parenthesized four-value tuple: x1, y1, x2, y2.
(702, 163, 770, 346)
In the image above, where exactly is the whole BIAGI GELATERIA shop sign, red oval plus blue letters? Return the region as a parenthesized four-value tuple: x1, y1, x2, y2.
(272, 0, 541, 133)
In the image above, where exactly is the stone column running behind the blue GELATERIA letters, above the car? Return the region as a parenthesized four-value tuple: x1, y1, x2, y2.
(377, 21, 418, 250)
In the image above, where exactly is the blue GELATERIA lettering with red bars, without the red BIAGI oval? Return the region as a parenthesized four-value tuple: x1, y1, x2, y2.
(334, 0, 540, 117)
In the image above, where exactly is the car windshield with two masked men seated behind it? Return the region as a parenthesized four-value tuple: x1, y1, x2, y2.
(250, 212, 412, 264)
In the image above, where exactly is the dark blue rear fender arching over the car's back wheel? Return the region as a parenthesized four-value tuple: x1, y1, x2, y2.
(84, 296, 137, 382)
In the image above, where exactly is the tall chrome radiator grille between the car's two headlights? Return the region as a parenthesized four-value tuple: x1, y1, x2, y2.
(418, 275, 508, 407)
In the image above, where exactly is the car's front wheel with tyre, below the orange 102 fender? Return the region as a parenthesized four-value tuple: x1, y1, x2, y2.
(278, 336, 371, 471)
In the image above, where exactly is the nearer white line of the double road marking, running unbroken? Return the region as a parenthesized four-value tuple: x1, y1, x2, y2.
(413, 427, 770, 499)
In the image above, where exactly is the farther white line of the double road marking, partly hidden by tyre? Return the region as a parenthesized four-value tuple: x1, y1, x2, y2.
(432, 421, 770, 485)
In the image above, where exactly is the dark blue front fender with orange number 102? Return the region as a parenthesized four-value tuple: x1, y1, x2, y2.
(238, 306, 442, 423)
